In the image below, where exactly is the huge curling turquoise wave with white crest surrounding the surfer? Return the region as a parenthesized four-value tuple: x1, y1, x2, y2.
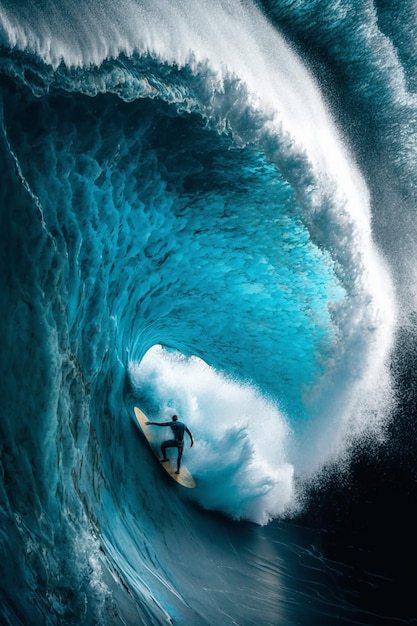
(0, 2, 410, 623)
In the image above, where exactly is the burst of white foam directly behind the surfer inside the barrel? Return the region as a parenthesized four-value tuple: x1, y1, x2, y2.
(130, 346, 294, 524)
